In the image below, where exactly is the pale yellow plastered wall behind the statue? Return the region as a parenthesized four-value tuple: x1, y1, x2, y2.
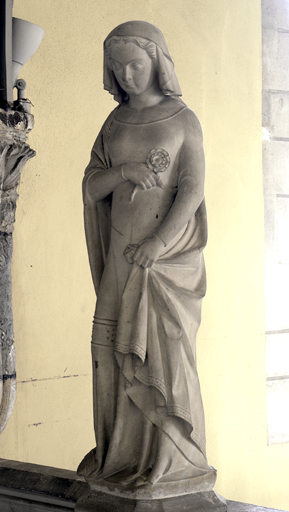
(0, 0, 289, 510)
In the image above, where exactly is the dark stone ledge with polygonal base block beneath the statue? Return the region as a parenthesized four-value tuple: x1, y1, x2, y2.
(0, 459, 281, 512)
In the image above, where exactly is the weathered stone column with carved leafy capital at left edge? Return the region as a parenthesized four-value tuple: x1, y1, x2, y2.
(0, 109, 35, 433)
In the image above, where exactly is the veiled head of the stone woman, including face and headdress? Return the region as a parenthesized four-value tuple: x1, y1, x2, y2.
(104, 21, 182, 103)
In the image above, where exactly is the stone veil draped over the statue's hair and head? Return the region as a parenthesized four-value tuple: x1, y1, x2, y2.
(103, 21, 182, 103)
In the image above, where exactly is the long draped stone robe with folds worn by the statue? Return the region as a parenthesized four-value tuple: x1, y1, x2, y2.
(79, 106, 216, 495)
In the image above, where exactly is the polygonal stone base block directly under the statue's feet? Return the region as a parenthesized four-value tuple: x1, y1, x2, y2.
(75, 491, 227, 512)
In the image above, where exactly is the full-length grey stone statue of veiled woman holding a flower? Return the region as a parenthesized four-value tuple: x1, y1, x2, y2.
(78, 21, 223, 508)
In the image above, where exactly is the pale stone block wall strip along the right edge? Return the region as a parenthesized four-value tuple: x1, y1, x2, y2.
(262, 0, 289, 444)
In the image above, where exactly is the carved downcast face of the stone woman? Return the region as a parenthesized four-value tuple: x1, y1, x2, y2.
(111, 40, 156, 96)
